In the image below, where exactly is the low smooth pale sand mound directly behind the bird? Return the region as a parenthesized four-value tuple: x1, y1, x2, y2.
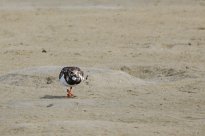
(0, 66, 145, 88)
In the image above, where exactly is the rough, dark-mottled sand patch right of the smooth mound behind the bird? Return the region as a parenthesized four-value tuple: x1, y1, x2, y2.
(120, 66, 197, 82)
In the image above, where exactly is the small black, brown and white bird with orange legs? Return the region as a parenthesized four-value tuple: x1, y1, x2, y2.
(59, 66, 85, 97)
